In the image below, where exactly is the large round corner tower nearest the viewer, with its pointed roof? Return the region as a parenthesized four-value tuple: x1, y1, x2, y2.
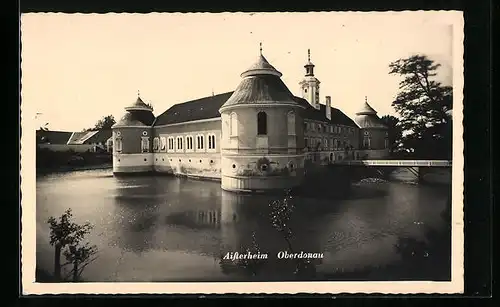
(219, 45, 304, 191)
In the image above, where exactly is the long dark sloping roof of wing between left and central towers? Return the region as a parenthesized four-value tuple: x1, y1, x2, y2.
(155, 92, 233, 126)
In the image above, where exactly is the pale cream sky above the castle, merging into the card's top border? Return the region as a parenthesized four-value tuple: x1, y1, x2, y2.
(21, 11, 456, 131)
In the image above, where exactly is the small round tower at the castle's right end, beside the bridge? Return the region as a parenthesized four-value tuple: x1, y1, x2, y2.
(354, 97, 389, 159)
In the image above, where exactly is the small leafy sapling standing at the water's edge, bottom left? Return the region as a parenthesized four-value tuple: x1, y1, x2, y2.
(47, 209, 96, 280)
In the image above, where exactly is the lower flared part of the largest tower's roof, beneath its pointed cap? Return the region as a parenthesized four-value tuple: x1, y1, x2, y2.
(222, 75, 295, 108)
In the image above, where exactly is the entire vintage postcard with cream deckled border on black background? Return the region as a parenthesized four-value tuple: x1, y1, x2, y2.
(21, 11, 464, 294)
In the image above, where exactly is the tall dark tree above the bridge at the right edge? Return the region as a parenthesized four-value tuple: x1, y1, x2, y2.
(389, 55, 453, 159)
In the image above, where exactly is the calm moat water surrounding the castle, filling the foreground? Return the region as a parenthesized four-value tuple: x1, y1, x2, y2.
(36, 170, 450, 282)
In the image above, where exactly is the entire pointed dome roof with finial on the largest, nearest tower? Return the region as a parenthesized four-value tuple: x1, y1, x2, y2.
(220, 42, 299, 110)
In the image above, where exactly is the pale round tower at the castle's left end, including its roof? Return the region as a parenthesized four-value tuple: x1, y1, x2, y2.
(112, 94, 155, 174)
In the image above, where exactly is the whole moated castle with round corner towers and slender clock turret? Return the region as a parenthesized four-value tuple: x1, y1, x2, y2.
(113, 46, 389, 191)
